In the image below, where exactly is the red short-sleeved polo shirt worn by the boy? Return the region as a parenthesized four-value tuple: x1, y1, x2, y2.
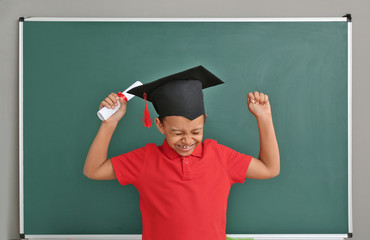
(111, 139, 252, 240)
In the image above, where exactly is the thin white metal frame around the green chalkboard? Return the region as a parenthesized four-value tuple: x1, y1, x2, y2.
(19, 14, 353, 239)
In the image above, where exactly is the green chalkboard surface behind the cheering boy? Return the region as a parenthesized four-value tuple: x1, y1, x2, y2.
(20, 21, 349, 238)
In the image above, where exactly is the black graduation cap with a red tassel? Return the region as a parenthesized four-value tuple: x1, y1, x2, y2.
(128, 65, 224, 127)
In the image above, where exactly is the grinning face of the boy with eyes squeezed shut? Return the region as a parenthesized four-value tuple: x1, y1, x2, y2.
(155, 115, 204, 156)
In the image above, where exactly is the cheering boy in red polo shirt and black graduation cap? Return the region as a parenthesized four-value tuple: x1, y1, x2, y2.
(84, 66, 280, 240)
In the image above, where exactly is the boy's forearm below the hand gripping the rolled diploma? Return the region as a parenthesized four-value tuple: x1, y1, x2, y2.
(83, 121, 117, 176)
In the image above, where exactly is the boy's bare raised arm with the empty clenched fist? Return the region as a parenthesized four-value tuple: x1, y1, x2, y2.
(246, 91, 280, 179)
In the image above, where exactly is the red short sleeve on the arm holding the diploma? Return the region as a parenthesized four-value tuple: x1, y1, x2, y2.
(111, 147, 145, 185)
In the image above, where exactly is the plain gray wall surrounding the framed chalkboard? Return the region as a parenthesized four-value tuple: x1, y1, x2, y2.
(0, 0, 370, 240)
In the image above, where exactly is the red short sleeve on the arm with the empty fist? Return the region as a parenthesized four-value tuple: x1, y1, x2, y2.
(217, 144, 252, 184)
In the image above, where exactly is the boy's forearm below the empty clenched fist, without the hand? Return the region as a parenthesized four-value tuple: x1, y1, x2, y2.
(257, 115, 280, 174)
